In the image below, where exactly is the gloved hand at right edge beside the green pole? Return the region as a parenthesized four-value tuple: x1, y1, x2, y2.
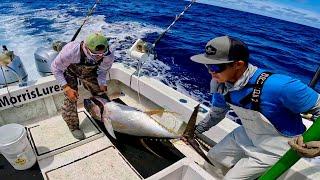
(288, 136, 320, 158)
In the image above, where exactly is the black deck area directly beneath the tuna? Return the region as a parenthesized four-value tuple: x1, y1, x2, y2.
(97, 119, 184, 178)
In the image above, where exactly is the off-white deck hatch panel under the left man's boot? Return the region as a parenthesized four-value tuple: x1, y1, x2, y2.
(27, 110, 103, 160)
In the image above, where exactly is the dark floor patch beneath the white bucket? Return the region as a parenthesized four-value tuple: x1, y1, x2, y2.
(0, 155, 43, 180)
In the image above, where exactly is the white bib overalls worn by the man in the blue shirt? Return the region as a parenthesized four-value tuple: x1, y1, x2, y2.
(208, 73, 291, 179)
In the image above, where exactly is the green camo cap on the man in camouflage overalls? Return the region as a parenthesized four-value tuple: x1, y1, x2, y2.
(85, 33, 109, 52)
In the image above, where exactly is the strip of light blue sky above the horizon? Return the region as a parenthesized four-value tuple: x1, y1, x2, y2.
(197, 0, 320, 29)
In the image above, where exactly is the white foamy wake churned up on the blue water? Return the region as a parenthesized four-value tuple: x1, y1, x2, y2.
(0, 3, 209, 101)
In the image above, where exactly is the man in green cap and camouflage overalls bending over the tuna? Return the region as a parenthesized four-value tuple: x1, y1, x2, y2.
(51, 33, 114, 140)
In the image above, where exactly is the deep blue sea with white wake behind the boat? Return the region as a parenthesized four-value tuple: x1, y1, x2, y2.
(0, 0, 320, 103)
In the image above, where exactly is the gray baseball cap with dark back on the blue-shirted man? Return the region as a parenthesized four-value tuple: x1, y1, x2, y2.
(190, 36, 249, 64)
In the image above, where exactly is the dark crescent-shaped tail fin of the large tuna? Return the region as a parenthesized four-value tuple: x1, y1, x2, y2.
(183, 104, 213, 165)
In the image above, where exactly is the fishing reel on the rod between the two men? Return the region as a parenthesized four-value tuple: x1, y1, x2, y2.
(128, 39, 156, 61)
